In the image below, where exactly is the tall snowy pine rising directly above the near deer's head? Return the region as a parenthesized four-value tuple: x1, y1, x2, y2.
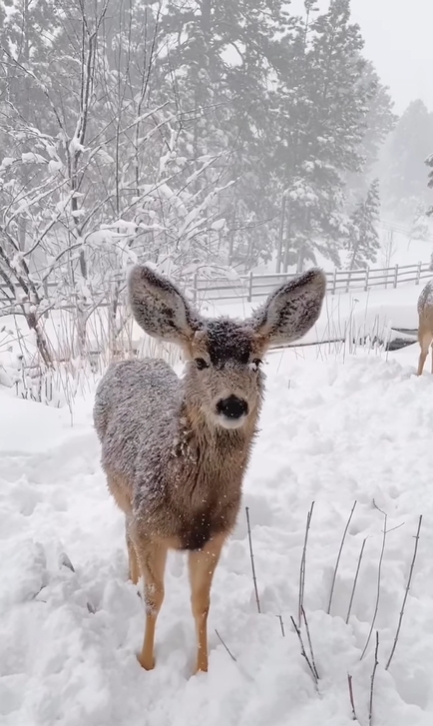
(151, 0, 293, 264)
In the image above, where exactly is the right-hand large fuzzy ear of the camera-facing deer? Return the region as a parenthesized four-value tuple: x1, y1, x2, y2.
(252, 269, 326, 347)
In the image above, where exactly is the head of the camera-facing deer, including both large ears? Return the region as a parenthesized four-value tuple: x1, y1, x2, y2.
(129, 265, 326, 429)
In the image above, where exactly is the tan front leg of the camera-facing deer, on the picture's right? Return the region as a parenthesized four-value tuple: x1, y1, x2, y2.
(189, 534, 226, 672)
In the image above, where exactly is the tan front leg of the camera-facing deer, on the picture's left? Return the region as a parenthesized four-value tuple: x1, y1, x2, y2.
(133, 538, 167, 671)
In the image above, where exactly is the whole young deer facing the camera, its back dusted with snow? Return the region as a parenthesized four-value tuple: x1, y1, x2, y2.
(94, 265, 326, 672)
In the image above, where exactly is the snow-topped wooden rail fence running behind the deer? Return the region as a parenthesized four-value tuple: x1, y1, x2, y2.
(0, 262, 433, 316)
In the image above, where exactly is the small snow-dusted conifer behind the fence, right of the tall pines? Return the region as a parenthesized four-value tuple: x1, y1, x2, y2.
(348, 179, 380, 270)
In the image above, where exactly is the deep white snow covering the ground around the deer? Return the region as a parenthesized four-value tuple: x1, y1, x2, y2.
(0, 338, 433, 726)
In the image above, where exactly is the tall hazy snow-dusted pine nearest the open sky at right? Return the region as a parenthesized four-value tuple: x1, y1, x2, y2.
(276, 0, 384, 269)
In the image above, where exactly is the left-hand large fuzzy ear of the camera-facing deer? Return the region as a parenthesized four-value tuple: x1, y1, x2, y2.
(128, 265, 200, 345)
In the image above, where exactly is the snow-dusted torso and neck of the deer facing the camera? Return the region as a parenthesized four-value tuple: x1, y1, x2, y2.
(95, 359, 261, 550)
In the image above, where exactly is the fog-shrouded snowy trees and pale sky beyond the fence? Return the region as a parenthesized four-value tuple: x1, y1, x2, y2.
(0, 0, 433, 360)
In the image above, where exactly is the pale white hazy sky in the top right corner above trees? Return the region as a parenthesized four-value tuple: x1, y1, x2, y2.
(350, 0, 433, 113)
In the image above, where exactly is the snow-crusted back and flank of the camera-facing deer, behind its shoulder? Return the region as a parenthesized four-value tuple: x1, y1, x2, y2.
(94, 359, 180, 487)
